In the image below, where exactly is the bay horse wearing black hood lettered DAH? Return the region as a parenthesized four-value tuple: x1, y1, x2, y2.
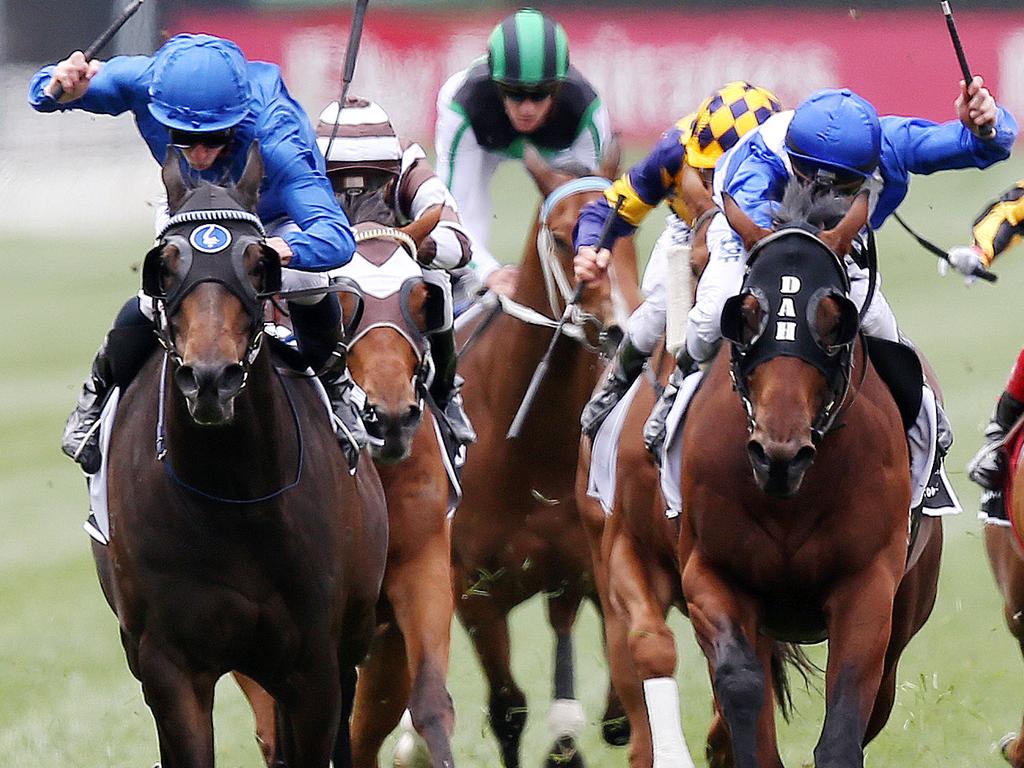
(678, 188, 942, 768)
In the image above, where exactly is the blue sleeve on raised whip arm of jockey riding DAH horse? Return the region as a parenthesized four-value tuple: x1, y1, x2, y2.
(882, 106, 1017, 174)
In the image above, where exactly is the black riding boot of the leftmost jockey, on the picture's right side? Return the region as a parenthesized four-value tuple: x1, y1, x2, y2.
(288, 295, 369, 469)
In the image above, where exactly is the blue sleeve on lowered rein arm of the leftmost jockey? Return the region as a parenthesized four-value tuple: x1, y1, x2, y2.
(260, 114, 355, 271)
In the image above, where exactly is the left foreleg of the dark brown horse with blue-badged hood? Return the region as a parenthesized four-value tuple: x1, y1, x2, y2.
(137, 639, 216, 768)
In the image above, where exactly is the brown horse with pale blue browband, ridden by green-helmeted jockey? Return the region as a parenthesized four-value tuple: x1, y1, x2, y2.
(453, 150, 639, 768)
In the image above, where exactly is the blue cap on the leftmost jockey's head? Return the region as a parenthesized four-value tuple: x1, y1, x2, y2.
(148, 35, 250, 132)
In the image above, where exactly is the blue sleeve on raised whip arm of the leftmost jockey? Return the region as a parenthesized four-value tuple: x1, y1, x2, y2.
(29, 56, 153, 115)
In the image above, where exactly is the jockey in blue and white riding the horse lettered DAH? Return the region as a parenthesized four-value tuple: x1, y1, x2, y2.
(680, 77, 1017, 505)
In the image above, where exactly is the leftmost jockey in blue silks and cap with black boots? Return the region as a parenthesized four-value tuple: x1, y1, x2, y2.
(29, 35, 362, 473)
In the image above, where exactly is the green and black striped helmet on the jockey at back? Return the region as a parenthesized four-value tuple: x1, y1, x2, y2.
(487, 8, 569, 88)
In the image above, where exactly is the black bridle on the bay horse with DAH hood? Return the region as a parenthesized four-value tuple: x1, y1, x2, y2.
(727, 226, 866, 445)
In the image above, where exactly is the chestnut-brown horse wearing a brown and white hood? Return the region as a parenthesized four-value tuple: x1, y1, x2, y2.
(240, 214, 455, 768)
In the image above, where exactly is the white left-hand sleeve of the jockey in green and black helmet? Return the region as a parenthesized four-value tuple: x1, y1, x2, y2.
(434, 73, 502, 283)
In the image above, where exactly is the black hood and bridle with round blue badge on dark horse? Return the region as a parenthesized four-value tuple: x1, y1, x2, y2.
(142, 209, 281, 390)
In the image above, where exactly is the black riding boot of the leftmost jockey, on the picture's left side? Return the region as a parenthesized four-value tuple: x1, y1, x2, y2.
(60, 298, 157, 474)
